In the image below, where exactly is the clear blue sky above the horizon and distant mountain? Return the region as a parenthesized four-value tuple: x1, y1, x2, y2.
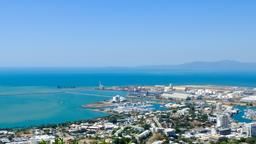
(0, 0, 256, 67)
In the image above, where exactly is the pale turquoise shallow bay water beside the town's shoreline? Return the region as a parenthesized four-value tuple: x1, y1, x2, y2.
(0, 87, 125, 128)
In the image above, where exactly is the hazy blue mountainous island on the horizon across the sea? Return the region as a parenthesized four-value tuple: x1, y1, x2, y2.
(137, 60, 256, 72)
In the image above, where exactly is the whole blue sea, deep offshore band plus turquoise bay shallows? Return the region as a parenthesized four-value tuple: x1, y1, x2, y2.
(0, 68, 256, 129)
